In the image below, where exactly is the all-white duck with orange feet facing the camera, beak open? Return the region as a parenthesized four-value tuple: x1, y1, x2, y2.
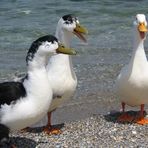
(116, 14, 148, 125)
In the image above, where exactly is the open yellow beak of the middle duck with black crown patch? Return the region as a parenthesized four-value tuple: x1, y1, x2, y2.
(73, 23, 88, 42)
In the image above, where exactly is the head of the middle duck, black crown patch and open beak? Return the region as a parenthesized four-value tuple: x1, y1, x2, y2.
(58, 14, 88, 42)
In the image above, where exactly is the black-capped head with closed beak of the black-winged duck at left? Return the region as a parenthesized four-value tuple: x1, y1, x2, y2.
(26, 35, 76, 62)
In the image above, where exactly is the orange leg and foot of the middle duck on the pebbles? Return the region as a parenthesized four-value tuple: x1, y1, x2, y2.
(44, 111, 61, 135)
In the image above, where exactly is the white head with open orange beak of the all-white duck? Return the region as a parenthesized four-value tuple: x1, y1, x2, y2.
(134, 14, 148, 40)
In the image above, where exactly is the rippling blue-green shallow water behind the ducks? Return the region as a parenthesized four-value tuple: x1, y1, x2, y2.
(0, 0, 148, 120)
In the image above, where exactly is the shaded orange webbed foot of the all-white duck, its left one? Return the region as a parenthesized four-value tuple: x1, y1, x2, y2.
(117, 113, 134, 122)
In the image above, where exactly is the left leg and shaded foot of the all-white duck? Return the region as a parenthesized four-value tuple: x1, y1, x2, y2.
(117, 102, 134, 122)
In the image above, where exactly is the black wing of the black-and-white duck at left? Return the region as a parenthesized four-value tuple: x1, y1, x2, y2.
(0, 82, 26, 105)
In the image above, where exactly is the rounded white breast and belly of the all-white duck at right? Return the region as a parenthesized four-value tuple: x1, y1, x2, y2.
(116, 64, 148, 106)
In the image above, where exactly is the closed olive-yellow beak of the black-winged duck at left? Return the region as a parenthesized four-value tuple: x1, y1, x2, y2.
(56, 43, 77, 55)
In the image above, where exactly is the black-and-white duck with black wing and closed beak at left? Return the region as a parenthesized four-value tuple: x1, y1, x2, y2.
(0, 35, 76, 144)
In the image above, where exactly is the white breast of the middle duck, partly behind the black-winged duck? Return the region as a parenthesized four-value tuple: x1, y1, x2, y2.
(47, 55, 77, 111)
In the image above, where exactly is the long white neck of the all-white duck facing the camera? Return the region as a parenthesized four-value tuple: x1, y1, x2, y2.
(130, 31, 147, 66)
